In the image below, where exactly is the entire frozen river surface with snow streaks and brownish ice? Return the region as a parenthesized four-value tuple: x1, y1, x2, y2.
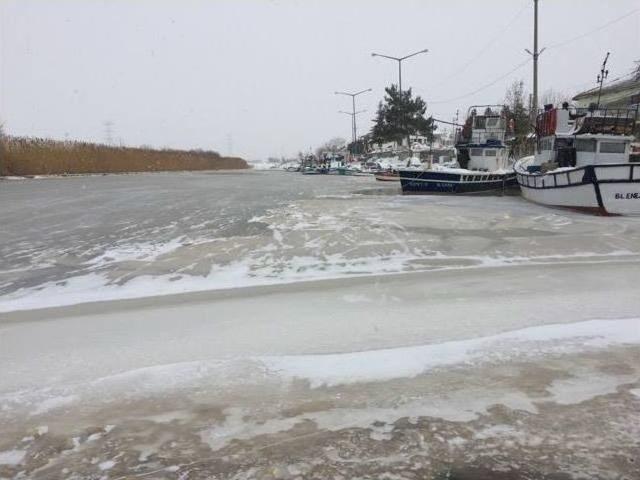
(0, 172, 640, 479)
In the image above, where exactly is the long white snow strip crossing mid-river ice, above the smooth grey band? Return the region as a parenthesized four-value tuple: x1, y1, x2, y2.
(0, 249, 636, 312)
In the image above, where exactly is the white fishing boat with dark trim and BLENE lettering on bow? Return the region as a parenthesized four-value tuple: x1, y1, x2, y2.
(515, 103, 640, 215)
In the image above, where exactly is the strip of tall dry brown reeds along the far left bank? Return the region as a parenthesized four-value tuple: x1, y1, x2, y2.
(0, 136, 249, 175)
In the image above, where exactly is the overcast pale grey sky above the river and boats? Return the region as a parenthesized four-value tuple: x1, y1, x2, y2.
(0, 0, 640, 159)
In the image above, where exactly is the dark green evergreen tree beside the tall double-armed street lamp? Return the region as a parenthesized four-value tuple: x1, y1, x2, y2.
(371, 85, 436, 143)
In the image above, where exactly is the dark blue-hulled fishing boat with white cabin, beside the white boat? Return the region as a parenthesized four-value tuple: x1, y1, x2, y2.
(399, 105, 517, 194)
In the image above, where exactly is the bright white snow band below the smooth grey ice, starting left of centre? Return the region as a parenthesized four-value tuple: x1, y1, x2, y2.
(262, 318, 640, 387)
